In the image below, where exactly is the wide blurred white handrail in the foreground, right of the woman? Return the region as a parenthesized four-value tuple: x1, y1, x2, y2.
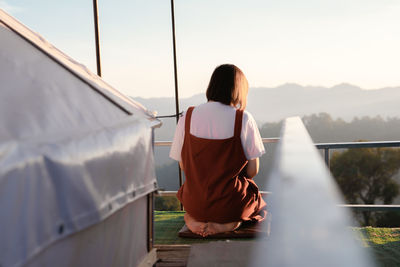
(249, 117, 374, 267)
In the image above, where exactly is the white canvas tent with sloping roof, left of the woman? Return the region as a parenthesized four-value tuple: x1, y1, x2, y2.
(0, 9, 159, 266)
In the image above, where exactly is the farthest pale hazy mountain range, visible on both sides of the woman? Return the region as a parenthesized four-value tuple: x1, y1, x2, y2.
(134, 83, 400, 140)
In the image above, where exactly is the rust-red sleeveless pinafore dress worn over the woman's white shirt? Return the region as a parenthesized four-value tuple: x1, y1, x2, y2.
(177, 107, 266, 223)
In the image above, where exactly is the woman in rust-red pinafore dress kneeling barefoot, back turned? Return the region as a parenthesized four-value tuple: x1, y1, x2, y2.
(170, 64, 266, 237)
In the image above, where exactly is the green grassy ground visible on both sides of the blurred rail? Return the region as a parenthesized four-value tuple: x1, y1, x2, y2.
(155, 211, 400, 267)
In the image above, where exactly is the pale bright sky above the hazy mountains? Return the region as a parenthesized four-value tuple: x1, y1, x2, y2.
(0, 0, 400, 98)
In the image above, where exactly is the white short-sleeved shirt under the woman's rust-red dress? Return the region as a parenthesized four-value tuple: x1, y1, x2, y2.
(169, 101, 265, 161)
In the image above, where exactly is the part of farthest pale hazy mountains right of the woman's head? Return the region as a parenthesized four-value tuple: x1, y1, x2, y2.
(248, 84, 400, 123)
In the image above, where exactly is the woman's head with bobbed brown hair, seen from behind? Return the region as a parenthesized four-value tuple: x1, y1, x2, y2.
(206, 64, 249, 109)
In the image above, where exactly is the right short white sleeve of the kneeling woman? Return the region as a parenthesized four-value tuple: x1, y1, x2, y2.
(240, 111, 265, 160)
